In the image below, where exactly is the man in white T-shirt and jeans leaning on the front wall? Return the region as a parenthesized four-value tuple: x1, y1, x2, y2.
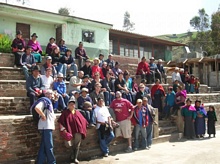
(94, 98, 115, 157)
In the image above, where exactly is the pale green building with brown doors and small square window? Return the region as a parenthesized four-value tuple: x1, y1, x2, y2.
(0, 3, 112, 58)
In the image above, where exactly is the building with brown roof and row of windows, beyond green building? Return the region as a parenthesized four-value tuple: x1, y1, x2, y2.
(109, 29, 186, 61)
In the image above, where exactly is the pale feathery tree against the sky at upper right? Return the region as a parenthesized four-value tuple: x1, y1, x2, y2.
(190, 8, 209, 31)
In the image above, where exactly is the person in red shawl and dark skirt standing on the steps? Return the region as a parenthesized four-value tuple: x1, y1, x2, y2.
(151, 79, 165, 119)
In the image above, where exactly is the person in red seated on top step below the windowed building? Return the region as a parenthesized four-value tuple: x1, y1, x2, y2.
(136, 57, 150, 81)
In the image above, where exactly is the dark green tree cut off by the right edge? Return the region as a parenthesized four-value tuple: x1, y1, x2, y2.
(211, 11, 220, 54)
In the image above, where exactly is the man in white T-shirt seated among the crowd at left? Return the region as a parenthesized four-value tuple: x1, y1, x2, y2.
(41, 67, 54, 90)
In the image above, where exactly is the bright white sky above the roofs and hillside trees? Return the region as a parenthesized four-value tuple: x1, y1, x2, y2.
(0, 0, 220, 36)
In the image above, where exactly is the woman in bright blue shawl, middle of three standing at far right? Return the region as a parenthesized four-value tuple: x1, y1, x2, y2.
(195, 100, 207, 138)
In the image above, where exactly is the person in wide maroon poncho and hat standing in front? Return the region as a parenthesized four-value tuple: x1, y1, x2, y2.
(58, 97, 88, 163)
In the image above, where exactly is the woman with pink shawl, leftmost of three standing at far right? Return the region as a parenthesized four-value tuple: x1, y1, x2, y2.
(181, 98, 196, 139)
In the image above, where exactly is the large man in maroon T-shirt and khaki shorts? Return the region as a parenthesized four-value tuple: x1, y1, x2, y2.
(110, 91, 134, 152)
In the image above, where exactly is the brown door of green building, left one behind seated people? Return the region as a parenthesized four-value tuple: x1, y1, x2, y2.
(16, 23, 30, 45)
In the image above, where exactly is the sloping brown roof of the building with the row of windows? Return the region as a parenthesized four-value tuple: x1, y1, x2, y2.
(109, 29, 186, 46)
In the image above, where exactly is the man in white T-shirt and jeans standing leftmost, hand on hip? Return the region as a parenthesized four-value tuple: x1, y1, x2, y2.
(35, 90, 56, 164)
